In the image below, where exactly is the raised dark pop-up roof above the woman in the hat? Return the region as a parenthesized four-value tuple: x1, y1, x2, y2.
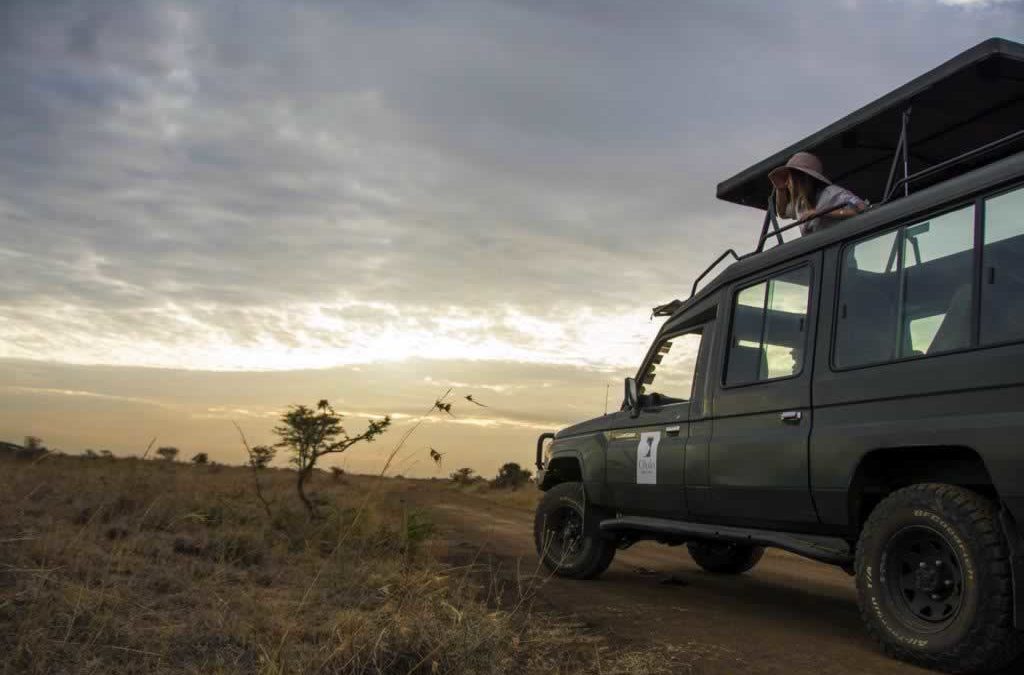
(718, 38, 1024, 209)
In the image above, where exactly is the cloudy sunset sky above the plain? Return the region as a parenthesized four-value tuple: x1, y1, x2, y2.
(0, 0, 1024, 475)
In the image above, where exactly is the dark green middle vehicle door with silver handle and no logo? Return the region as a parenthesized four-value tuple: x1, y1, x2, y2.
(702, 252, 821, 526)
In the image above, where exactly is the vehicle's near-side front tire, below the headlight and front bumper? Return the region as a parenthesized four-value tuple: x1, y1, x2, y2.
(534, 482, 615, 579)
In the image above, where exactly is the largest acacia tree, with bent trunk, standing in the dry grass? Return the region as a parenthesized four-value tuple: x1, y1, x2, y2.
(273, 398, 391, 517)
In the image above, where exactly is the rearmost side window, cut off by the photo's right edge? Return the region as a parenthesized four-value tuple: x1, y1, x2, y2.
(981, 188, 1024, 344)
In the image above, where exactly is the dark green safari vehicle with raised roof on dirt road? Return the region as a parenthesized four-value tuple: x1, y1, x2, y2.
(535, 39, 1024, 673)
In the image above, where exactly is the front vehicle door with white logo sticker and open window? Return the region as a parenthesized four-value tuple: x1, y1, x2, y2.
(605, 327, 703, 517)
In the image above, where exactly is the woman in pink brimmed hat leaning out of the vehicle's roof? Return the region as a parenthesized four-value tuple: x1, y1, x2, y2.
(768, 153, 867, 235)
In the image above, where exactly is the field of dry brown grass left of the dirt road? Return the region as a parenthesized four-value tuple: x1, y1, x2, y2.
(0, 457, 664, 674)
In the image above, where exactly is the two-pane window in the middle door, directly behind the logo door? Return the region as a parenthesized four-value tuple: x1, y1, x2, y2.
(725, 265, 811, 386)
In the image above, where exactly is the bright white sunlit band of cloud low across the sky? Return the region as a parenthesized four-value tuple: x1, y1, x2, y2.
(0, 301, 658, 368)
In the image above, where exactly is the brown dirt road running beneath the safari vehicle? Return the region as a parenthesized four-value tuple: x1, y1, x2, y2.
(395, 481, 970, 675)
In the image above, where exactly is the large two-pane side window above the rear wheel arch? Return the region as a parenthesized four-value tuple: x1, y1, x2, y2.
(834, 206, 974, 368)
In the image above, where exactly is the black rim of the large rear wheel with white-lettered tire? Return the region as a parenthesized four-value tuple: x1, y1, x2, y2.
(883, 526, 964, 633)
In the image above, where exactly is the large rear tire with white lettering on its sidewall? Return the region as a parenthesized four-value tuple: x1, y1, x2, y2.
(856, 483, 1024, 673)
